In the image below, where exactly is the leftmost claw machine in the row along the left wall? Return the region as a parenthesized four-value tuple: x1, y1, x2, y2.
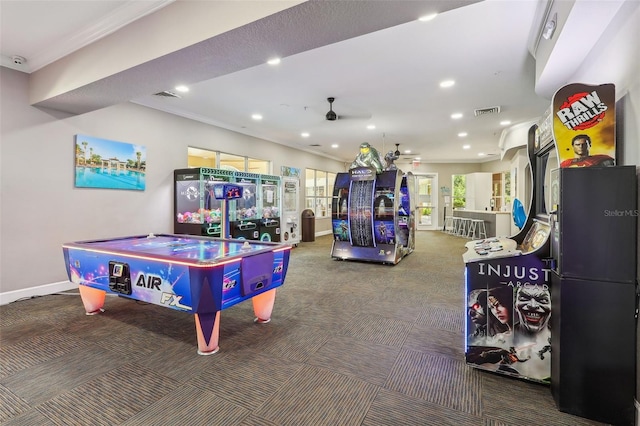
(173, 167, 233, 238)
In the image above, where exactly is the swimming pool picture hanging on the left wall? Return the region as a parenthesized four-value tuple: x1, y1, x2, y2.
(75, 135, 147, 191)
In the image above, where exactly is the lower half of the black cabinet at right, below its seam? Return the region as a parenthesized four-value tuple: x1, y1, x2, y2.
(551, 274, 636, 425)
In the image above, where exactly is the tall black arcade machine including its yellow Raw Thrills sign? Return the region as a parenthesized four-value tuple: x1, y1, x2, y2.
(551, 84, 638, 425)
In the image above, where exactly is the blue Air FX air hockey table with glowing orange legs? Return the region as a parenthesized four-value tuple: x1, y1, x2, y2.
(62, 234, 291, 355)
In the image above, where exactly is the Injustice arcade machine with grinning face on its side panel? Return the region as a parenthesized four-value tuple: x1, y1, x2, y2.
(463, 105, 558, 383)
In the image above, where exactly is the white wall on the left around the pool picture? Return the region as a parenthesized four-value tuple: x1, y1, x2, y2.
(0, 67, 344, 303)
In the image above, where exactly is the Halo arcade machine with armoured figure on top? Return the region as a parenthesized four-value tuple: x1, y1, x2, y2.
(331, 143, 415, 265)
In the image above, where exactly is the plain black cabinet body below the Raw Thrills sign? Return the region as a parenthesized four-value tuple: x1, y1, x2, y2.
(551, 166, 638, 425)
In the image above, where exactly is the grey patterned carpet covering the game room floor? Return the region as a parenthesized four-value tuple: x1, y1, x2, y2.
(0, 231, 600, 426)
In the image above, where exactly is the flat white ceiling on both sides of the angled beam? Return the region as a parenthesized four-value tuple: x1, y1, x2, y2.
(0, 0, 550, 163)
